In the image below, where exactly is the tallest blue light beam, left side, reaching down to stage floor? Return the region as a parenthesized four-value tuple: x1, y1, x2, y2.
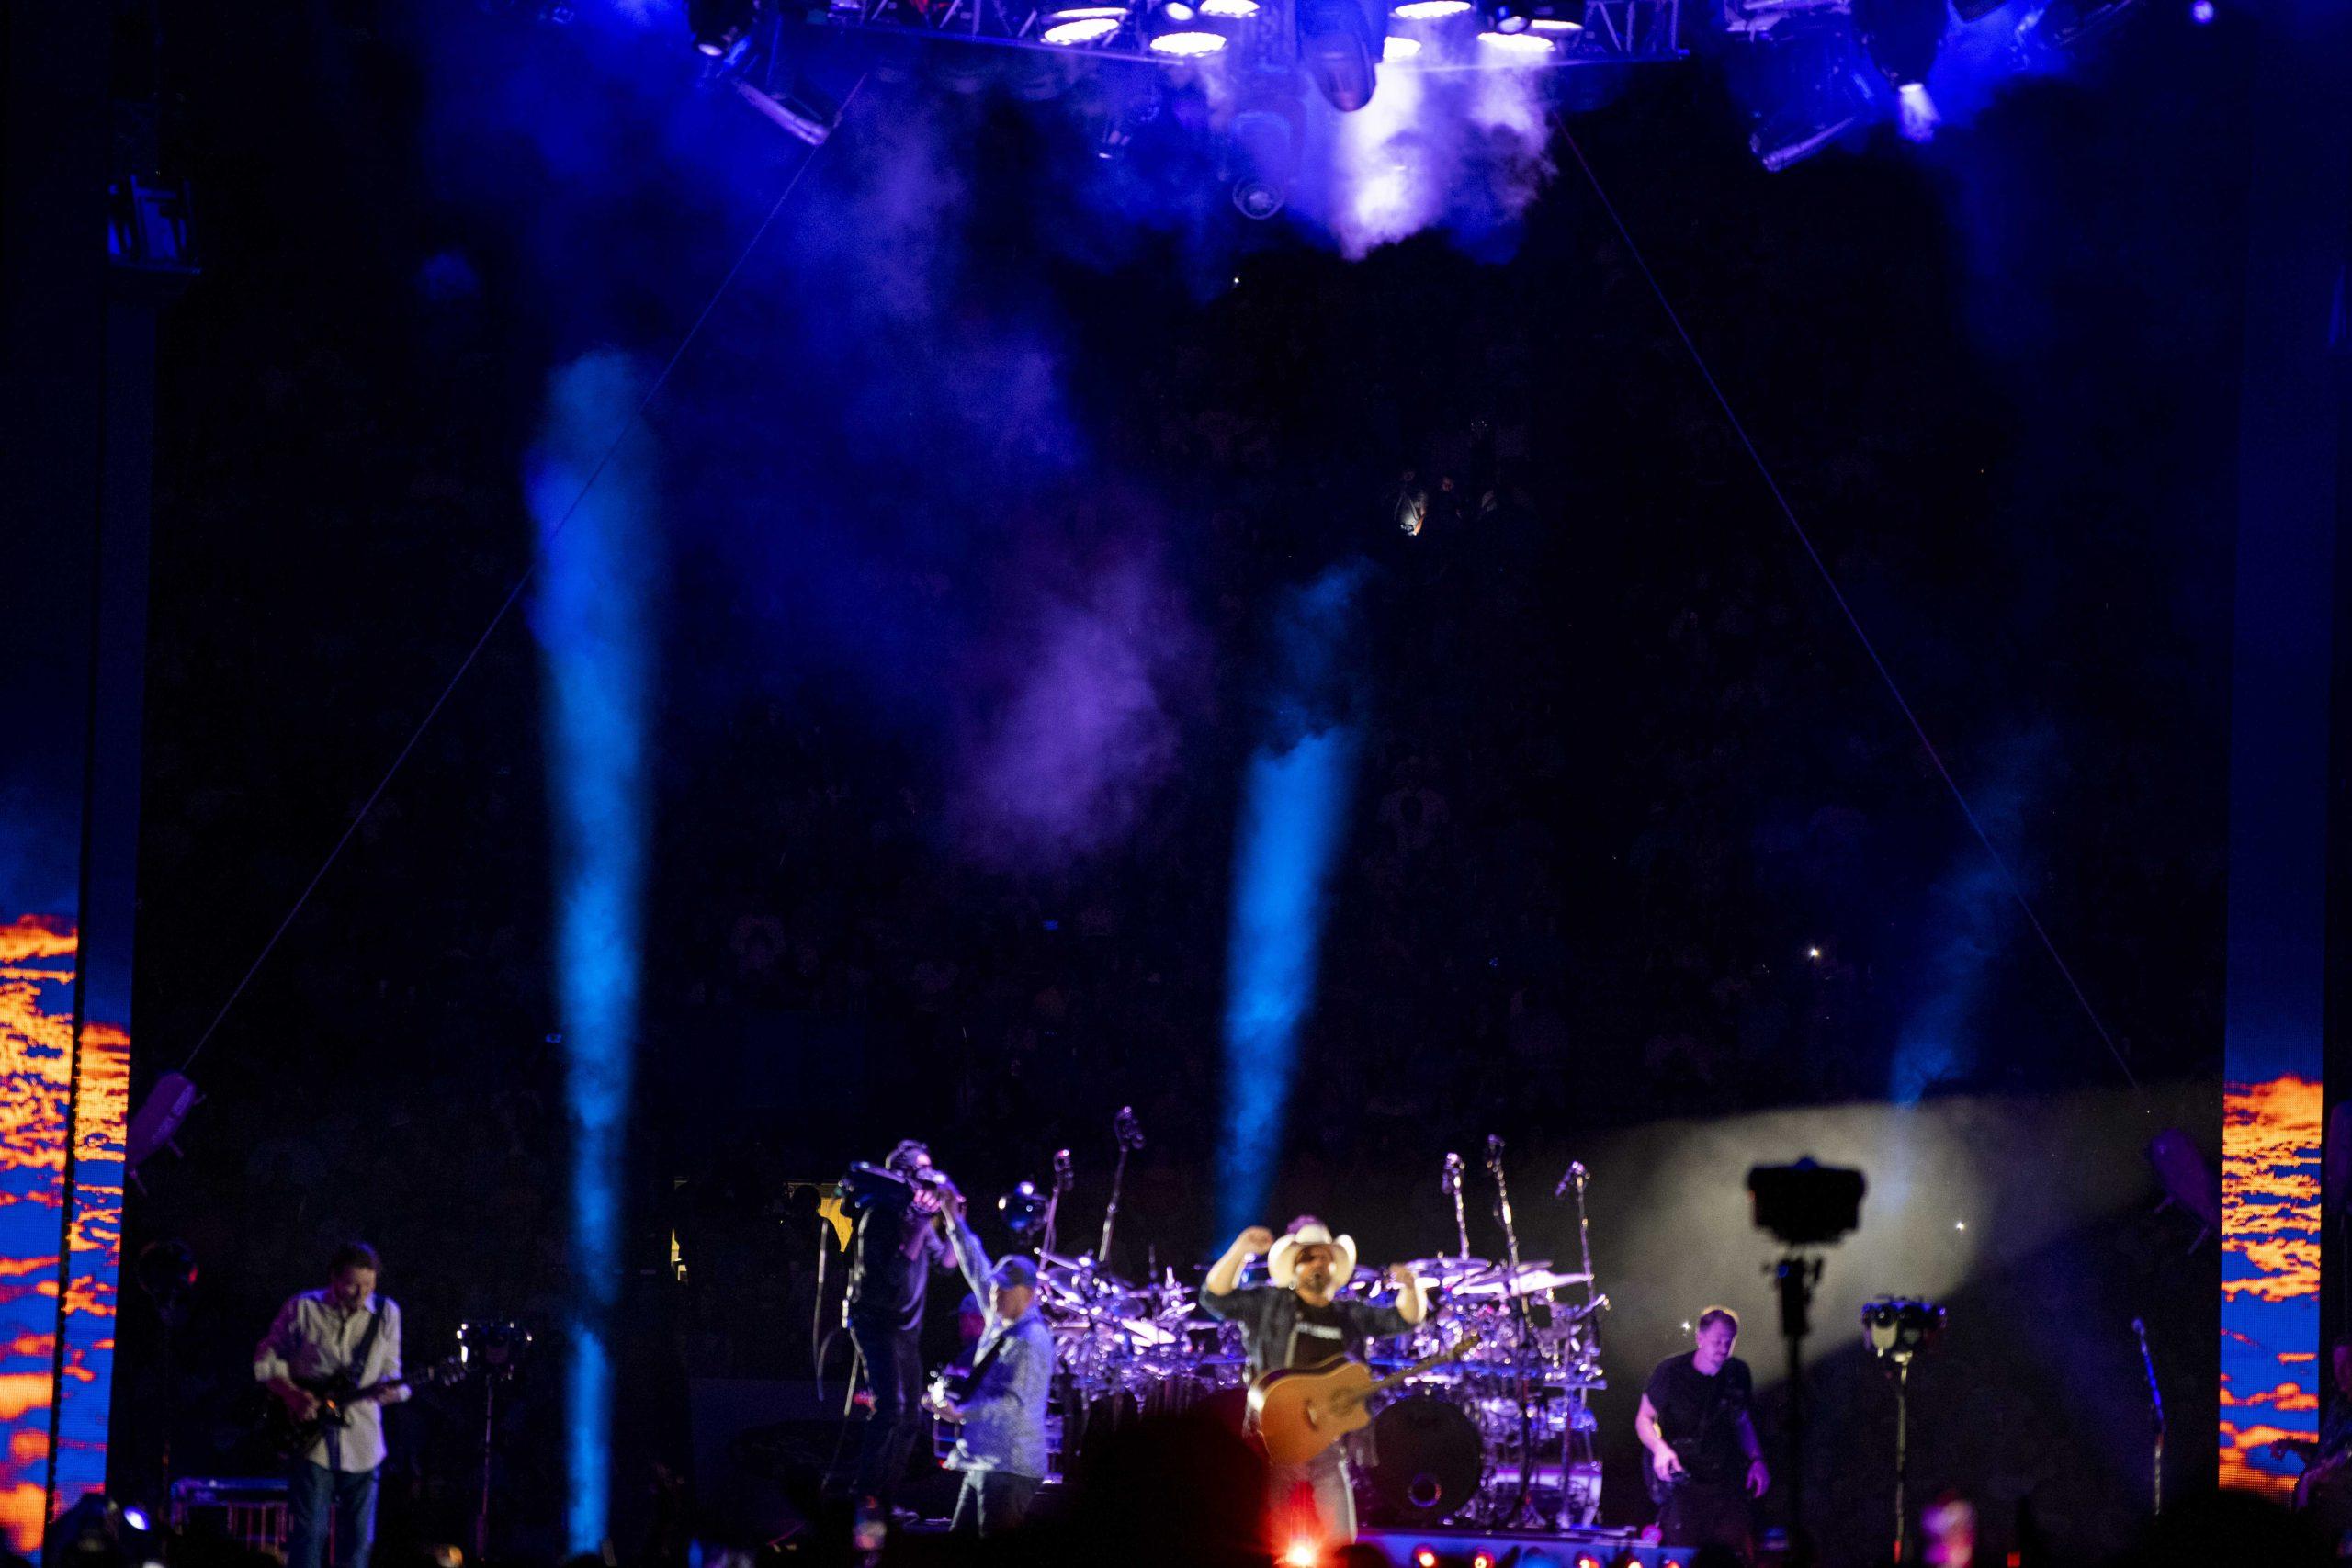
(526, 353, 659, 1551)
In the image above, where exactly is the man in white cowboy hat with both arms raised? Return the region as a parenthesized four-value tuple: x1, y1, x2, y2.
(1200, 1215, 1428, 1542)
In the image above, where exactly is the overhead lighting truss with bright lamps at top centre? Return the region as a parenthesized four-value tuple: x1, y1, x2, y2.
(809, 0, 1681, 71)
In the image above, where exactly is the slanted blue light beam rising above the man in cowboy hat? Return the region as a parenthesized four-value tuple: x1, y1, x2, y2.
(1218, 562, 1364, 1235)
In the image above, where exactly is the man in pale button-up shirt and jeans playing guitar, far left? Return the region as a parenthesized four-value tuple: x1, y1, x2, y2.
(254, 1241, 409, 1568)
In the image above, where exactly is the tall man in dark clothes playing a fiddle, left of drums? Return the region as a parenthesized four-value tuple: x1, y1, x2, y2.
(842, 1140, 955, 1551)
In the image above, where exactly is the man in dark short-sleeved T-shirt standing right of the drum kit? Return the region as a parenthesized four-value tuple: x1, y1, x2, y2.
(1634, 1307, 1771, 1561)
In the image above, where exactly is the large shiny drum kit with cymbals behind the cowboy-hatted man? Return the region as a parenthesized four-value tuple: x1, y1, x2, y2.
(964, 1114, 1609, 1530)
